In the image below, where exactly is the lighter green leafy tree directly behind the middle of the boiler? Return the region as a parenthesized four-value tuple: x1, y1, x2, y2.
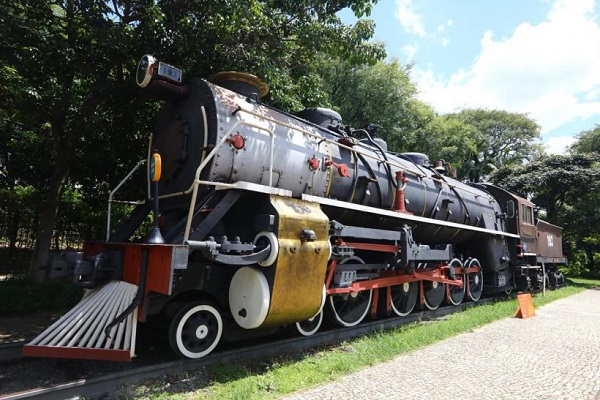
(318, 60, 476, 174)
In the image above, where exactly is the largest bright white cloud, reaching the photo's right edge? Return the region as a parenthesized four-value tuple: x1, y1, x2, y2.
(413, 0, 600, 142)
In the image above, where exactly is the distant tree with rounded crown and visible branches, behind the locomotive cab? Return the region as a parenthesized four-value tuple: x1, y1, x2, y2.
(445, 109, 542, 182)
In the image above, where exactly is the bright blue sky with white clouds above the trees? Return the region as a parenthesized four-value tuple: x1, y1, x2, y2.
(341, 0, 600, 153)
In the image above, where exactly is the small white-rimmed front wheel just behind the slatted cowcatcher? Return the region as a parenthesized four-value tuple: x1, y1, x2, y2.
(169, 302, 223, 358)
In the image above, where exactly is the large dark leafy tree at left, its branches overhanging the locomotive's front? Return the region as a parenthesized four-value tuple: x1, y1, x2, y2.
(0, 0, 385, 275)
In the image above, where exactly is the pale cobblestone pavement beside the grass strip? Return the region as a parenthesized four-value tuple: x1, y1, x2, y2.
(284, 289, 600, 400)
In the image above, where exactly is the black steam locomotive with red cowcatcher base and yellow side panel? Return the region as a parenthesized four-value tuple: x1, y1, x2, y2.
(24, 55, 566, 361)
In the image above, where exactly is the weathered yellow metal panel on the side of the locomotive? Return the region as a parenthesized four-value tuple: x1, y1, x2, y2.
(263, 196, 330, 326)
